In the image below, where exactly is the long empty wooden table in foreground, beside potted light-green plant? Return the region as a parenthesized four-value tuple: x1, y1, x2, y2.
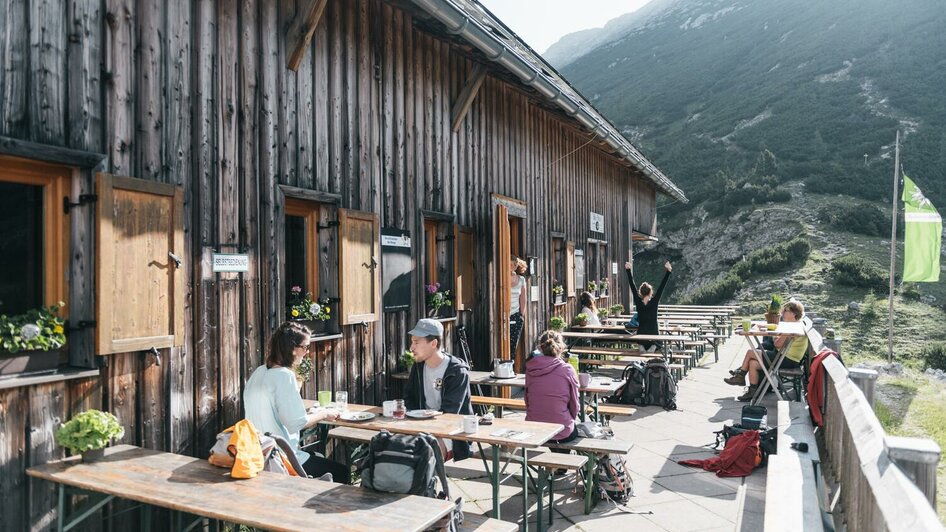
(26, 445, 453, 531)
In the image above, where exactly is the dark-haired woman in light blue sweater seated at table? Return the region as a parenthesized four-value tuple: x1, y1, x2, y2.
(243, 322, 351, 484)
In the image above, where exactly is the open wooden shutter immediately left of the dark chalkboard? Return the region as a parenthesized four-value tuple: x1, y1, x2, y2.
(338, 209, 381, 325)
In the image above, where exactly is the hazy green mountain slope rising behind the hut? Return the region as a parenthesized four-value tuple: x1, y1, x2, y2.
(546, 0, 946, 304)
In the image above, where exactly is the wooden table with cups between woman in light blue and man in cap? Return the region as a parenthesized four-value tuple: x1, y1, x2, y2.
(303, 400, 564, 530)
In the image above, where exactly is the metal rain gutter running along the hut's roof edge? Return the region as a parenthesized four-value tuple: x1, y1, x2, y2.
(412, 0, 688, 203)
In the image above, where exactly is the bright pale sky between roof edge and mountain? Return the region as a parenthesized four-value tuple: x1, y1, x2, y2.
(479, 0, 648, 54)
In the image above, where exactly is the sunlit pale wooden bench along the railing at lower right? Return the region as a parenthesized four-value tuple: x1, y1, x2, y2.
(765, 401, 834, 532)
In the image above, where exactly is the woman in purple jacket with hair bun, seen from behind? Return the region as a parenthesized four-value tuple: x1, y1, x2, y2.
(525, 331, 578, 453)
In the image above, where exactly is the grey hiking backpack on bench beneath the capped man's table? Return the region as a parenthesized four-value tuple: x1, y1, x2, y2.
(359, 430, 463, 532)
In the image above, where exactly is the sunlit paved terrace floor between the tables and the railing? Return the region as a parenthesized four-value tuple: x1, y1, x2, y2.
(447, 337, 776, 532)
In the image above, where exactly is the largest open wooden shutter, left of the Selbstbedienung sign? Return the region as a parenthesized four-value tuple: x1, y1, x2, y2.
(96, 174, 186, 355)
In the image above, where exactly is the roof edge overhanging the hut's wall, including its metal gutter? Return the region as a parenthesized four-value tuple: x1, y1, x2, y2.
(411, 0, 688, 203)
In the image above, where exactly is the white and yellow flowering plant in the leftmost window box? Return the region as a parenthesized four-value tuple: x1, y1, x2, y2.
(0, 301, 66, 353)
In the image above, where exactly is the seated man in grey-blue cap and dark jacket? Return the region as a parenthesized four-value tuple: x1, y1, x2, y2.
(404, 319, 473, 461)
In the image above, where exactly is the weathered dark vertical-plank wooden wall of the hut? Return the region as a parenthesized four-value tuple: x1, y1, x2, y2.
(0, 0, 655, 530)
